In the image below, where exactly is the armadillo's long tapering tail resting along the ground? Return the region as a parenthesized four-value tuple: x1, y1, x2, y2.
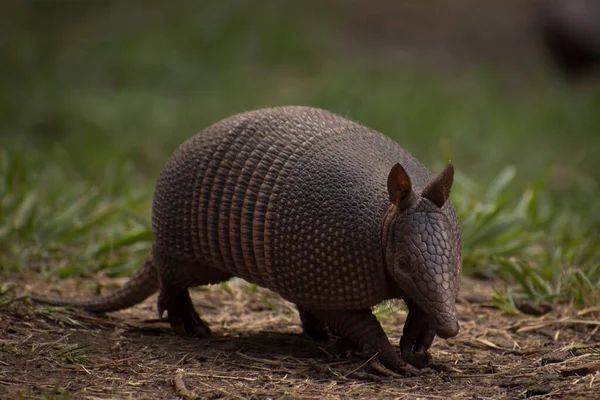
(30, 254, 160, 313)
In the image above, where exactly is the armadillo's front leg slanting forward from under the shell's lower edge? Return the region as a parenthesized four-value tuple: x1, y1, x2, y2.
(312, 309, 408, 372)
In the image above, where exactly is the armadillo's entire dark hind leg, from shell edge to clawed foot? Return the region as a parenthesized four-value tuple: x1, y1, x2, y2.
(154, 251, 231, 337)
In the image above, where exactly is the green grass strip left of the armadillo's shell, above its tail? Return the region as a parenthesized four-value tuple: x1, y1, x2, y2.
(0, 150, 152, 276)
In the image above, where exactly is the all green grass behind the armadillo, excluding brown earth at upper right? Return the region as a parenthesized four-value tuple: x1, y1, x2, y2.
(0, 0, 600, 307)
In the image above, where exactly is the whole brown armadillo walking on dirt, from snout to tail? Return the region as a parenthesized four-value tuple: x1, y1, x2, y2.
(32, 106, 462, 371)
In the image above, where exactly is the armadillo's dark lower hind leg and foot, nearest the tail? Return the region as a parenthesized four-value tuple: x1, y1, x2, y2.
(158, 287, 210, 337)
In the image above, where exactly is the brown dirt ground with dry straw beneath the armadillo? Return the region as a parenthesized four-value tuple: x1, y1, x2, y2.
(0, 276, 600, 399)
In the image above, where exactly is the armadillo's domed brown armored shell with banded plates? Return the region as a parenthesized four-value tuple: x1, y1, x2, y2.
(153, 107, 458, 309)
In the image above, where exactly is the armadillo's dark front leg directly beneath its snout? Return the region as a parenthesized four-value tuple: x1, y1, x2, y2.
(400, 301, 435, 368)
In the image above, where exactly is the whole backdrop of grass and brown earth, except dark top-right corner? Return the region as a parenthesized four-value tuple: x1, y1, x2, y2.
(0, 0, 600, 306)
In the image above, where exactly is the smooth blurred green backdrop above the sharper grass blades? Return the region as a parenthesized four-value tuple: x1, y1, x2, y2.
(0, 0, 600, 181)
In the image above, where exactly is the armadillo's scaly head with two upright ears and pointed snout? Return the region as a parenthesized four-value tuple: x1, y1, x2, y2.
(382, 163, 462, 338)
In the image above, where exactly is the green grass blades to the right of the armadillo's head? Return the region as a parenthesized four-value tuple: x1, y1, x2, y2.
(454, 168, 600, 308)
